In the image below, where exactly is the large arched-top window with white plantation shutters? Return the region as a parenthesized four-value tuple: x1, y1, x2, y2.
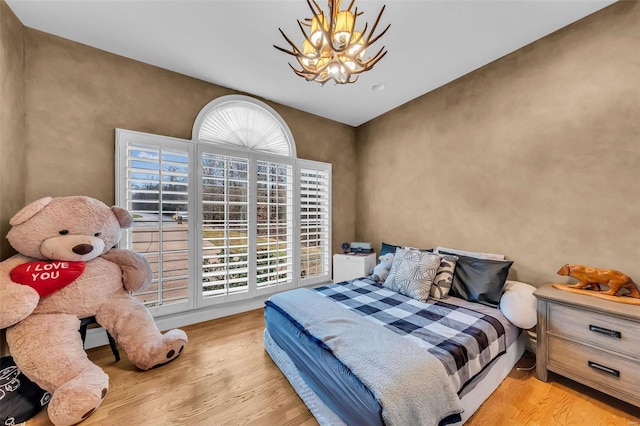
(116, 96, 331, 315)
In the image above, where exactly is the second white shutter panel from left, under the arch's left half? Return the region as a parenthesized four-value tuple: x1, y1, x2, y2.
(201, 153, 249, 298)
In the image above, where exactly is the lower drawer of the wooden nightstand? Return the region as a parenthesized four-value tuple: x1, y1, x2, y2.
(547, 336, 640, 406)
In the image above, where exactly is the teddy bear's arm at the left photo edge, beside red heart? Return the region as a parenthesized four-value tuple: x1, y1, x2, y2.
(0, 254, 40, 329)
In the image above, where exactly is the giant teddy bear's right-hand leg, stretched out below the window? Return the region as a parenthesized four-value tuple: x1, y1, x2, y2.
(96, 296, 187, 370)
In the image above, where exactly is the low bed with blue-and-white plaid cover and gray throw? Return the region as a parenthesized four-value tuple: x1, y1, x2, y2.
(264, 246, 526, 425)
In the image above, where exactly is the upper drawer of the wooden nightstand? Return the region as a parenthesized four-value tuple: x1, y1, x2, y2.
(547, 304, 640, 360)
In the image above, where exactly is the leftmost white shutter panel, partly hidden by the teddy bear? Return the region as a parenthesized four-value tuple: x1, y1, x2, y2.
(115, 131, 189, 311)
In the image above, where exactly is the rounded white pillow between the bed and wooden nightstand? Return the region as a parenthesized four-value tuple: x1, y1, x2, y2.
(500, 280, 538, 330)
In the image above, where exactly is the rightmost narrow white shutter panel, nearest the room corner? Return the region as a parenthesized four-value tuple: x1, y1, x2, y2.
(298, 160, 331, 282)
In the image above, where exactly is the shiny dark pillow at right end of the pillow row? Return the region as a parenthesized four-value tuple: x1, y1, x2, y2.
(450, 252, 513, 308)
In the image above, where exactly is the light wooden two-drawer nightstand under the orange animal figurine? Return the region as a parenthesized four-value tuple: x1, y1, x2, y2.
(534, 284, 640, 407)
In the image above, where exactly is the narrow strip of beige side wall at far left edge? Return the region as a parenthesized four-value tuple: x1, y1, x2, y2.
(0, 1, 25, 260)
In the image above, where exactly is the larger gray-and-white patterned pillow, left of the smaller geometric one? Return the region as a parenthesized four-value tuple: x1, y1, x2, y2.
(384, 248, 440, 302)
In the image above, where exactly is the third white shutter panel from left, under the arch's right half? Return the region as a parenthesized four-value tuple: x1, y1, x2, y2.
(256, 160, 293, 288)
